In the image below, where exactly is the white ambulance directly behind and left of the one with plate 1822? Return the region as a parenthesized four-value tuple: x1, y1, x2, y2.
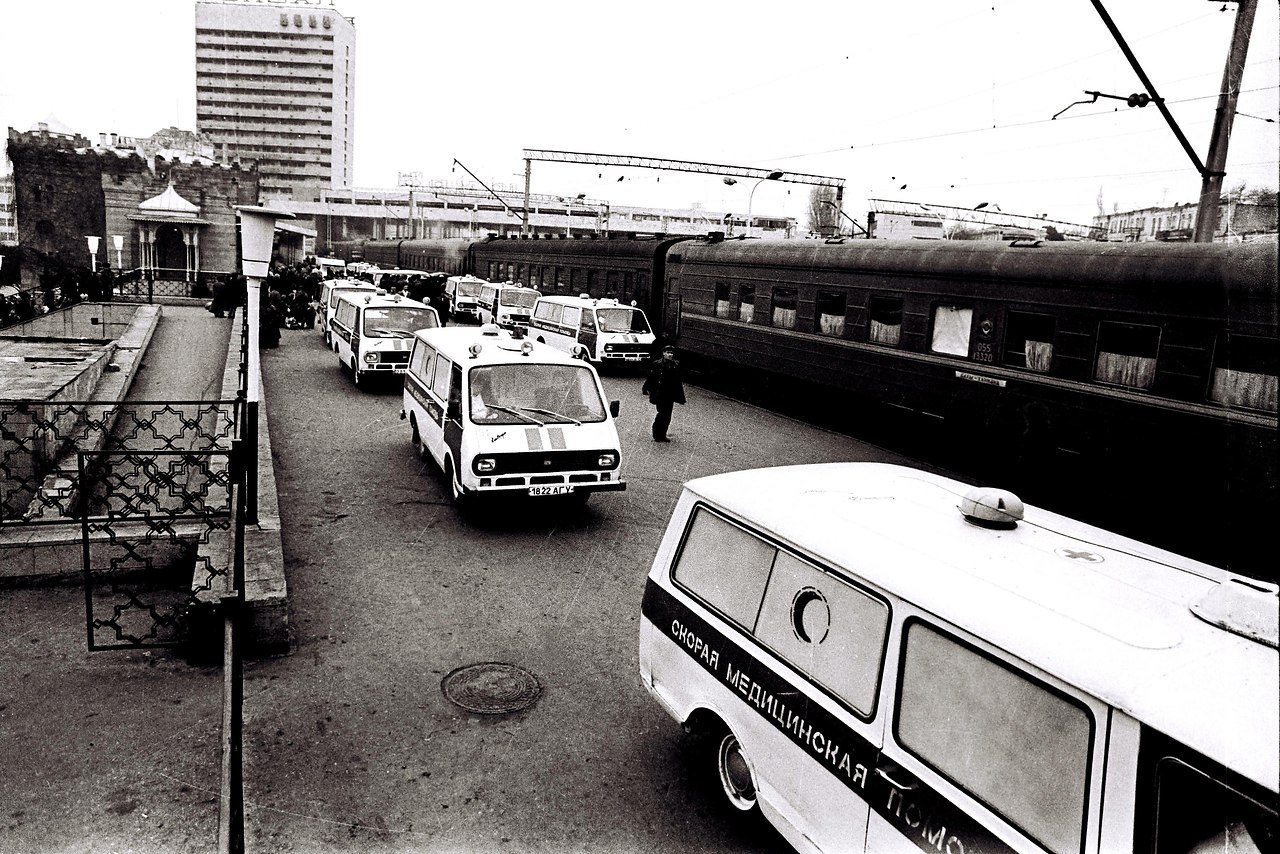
(330, 289, 440, 385)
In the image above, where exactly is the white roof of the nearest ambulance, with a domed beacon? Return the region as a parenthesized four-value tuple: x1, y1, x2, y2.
(685, 463, 1280, 791)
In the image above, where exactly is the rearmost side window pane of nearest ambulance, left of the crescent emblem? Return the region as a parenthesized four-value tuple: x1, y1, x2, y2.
(673, 507, 777, 631)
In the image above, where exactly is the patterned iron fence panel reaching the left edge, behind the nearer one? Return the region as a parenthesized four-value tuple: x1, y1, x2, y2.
(0, 399, 242, 525)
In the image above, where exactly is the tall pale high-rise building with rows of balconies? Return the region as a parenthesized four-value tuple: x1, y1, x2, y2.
(196, 0, 356, 201)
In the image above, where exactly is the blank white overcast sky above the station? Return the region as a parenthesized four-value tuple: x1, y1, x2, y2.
(0, 0, 1280, 223)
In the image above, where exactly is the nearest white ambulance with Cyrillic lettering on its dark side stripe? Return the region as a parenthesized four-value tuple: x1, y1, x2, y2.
(639, 463, 1280, 854)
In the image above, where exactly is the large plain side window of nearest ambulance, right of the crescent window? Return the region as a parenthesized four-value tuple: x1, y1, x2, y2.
(893, 620, 1093, 854)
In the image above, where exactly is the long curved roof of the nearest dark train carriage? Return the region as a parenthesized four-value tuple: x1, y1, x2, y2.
(669, 241, 1277, 300)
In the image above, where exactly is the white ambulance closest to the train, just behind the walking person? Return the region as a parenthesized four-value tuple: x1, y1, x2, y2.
(529, 296, 654, 365)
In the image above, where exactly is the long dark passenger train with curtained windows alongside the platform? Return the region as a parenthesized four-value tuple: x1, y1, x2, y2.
(332, 237, 1280, 577)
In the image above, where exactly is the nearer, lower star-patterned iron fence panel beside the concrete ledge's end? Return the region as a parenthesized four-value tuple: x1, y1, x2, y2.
(77, 449, 238, 650)
